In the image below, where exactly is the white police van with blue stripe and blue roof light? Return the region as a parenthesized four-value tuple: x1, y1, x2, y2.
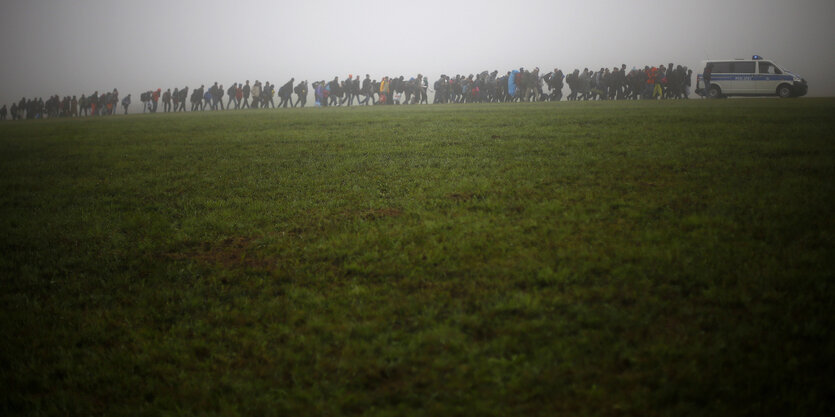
(696, 55, 809, 98)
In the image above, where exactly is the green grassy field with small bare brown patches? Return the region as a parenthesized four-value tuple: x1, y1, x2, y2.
(0, 99, 835, 416)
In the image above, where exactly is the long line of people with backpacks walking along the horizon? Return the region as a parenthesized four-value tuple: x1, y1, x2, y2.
(0, 63, 693, 120)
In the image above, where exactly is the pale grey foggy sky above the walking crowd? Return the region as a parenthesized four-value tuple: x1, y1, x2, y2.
(0, 0, 835, 112)
